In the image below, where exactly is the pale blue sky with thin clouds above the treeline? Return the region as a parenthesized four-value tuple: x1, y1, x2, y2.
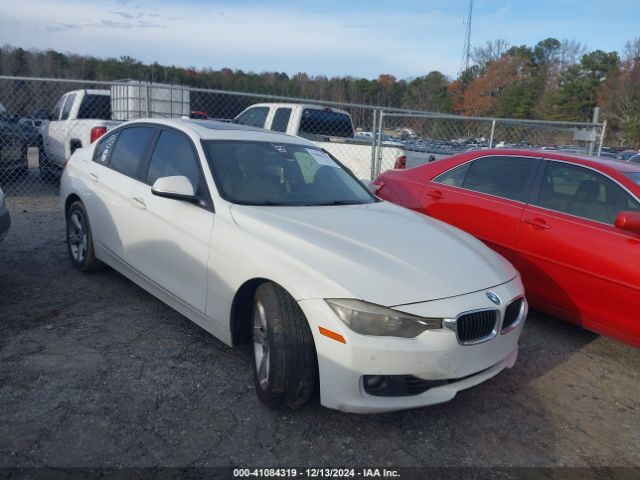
(0, 0, 640, 79)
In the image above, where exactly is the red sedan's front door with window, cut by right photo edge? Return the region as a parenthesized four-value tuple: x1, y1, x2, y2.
(513, 161, 640, 345)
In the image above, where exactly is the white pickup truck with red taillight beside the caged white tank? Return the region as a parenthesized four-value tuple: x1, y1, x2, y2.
(40, 90, 122, 178)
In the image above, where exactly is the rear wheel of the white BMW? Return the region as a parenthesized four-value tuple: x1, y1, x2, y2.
(67, 201, 103, 272)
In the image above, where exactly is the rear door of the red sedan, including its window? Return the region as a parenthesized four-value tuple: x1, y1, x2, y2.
(421, 155, 541, 259)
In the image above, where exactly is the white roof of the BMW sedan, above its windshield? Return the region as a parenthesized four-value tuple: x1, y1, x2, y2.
(125, 118, 317, 148)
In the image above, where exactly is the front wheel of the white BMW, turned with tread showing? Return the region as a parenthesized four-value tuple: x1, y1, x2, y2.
(251, 283, 318, 409)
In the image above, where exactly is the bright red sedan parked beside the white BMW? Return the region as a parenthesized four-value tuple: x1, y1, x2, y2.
(373, 149, 640, 347)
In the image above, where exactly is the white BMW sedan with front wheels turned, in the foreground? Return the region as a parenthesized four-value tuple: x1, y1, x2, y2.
(60, 119, 527, 412)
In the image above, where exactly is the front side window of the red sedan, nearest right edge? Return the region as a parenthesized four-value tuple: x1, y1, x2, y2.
(536, 162, 640, 225)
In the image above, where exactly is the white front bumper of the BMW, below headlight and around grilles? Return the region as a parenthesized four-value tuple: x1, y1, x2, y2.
(299, 277, 527, 413)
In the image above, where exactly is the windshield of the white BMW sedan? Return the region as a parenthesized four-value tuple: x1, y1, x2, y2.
(202, 140, 376, 206)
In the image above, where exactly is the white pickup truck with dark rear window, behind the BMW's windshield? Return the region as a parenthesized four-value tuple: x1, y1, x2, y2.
(233, 103, 405, 180)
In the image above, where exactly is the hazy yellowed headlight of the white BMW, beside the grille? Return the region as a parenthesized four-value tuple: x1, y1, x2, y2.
(325, 298, 442, 338)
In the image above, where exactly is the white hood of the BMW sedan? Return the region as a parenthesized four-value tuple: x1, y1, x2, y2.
(231, 202, 517, 306)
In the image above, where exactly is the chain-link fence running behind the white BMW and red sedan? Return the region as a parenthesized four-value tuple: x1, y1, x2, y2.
(0, 76, 603, 204)
